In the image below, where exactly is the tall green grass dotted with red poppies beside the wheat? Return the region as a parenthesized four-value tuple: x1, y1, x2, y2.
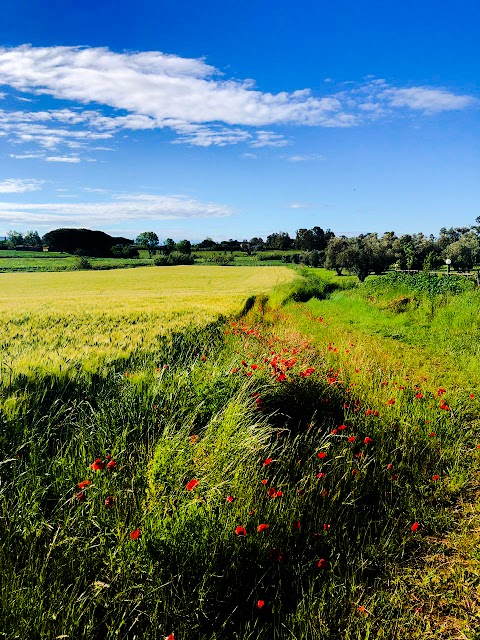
(0, 272, 479, 640)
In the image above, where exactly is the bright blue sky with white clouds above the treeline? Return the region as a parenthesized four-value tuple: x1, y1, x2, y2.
(0, 0, 480, 240)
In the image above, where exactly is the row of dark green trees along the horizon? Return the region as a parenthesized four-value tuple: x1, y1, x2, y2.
(0, 216, 480, 280)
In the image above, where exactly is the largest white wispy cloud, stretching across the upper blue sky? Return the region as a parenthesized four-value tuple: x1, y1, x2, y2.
(0, 45, 478, 151)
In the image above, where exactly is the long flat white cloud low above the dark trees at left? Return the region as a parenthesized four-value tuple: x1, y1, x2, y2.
(0, 194, 233, 227)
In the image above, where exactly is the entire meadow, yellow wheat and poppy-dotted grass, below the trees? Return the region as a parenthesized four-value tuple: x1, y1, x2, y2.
(0, 267, 480, 640)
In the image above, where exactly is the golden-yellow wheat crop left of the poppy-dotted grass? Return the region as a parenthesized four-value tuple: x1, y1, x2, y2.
(0, 266, 295, 375)
